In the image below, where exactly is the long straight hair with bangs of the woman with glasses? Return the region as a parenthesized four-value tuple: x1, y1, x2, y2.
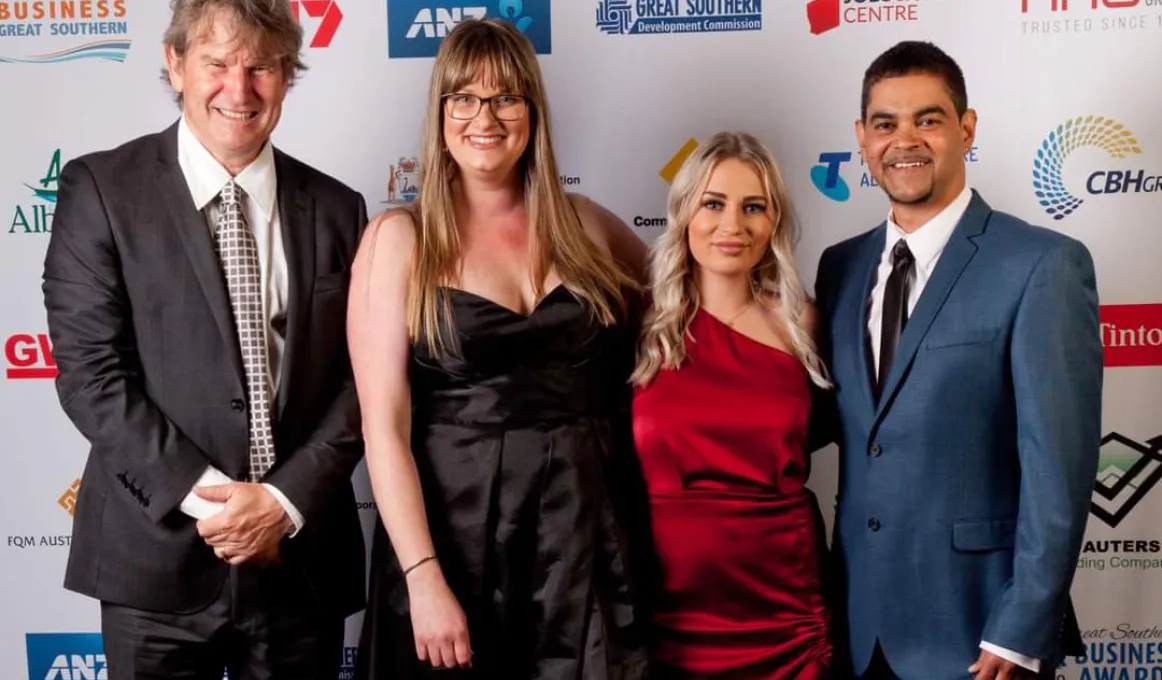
(408, 20, 634, 353)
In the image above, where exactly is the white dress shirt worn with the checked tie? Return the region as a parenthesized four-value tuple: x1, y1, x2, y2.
(178, 116, 303, 534)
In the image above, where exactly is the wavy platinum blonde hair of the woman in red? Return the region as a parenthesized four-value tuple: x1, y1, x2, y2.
(631, 133, 831, 387)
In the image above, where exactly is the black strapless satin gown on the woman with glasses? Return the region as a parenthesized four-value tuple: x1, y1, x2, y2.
(356, 287, 646, 680)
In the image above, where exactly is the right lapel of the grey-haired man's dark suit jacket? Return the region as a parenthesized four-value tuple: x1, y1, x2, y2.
(274, 149, 315, 416)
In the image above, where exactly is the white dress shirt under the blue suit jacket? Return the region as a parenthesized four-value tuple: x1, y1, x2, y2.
(868, 186, 1041, 673)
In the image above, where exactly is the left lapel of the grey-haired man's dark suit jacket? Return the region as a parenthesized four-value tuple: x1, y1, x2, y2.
(155, 123, 245, 384)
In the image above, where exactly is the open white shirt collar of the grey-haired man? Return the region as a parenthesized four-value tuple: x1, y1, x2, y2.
(178, 115, 278, 220)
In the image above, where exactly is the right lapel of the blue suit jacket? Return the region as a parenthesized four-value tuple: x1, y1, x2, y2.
(876, 191, 991, 424)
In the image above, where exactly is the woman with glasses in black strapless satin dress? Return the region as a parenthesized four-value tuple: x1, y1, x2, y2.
(349, 21, 645, 680)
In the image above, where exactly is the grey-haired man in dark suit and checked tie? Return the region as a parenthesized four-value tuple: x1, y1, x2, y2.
(43, 0, 367, 680)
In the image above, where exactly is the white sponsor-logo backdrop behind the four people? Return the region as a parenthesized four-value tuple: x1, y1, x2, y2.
(0, 0, 1162, 680)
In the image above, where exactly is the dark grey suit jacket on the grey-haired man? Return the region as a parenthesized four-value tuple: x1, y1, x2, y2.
(43, 124, 367, 616)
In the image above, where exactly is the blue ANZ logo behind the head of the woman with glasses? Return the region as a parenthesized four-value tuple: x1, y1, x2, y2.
(387, 0, 552, 59)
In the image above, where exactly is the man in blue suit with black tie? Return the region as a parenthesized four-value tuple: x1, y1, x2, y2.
(816, 42, 1103, 680)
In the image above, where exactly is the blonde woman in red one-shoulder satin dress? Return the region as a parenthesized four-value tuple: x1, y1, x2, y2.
(633, 134, 831, 680)
